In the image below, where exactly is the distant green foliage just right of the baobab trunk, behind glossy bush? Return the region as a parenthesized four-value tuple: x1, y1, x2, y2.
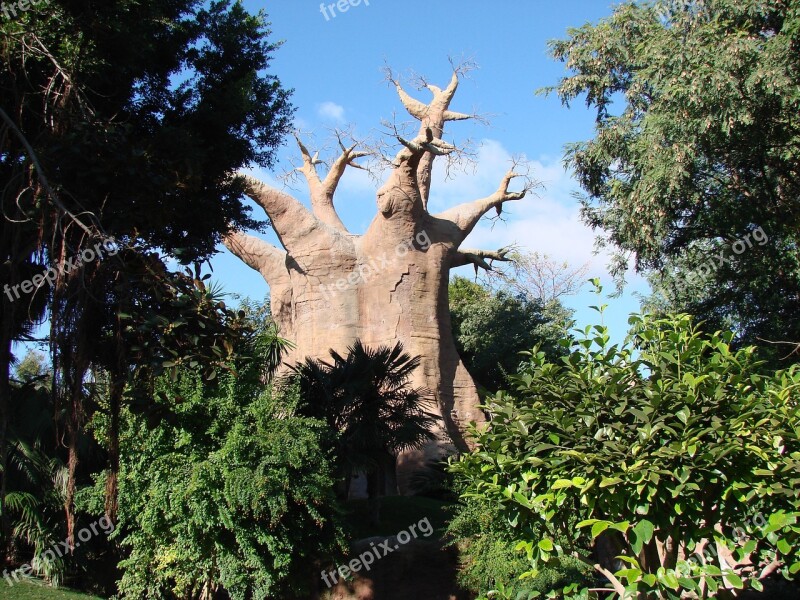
(450, 277, 569, 391)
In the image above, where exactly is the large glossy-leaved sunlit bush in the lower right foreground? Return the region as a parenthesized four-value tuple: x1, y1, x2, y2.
(453, 308, 800, 598)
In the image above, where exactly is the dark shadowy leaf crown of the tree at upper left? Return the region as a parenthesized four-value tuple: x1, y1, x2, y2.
(0, 0, 292, 261)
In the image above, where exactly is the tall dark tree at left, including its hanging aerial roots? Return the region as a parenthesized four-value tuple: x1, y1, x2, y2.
(0, 0, 292, 556)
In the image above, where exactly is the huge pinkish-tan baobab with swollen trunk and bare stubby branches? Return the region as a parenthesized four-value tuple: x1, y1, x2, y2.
(225, 68, 531, 478)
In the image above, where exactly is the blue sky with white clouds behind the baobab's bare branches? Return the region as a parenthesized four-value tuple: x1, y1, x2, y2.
(212, 0, 647, 340)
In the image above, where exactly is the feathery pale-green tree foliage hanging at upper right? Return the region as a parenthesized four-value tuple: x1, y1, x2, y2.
(551, 0, 800, 343)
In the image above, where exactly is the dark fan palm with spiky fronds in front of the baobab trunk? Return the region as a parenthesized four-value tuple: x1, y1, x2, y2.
(292, 340, 439, 523)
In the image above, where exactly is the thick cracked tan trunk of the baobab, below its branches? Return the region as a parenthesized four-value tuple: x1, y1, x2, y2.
(271, 223, 483, 440)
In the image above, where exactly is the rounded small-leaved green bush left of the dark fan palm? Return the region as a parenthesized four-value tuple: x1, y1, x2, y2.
(111, 332, 343, 599)
